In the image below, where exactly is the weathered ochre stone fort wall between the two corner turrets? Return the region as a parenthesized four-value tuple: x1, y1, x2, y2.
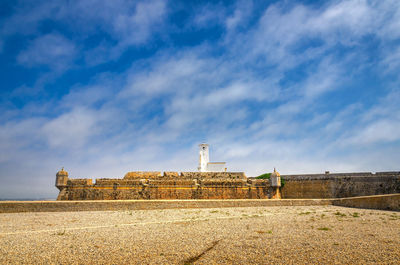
(57, 172, 272, 200)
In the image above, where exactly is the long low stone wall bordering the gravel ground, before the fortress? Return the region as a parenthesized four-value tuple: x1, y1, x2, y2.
(0, 194, 400, 213)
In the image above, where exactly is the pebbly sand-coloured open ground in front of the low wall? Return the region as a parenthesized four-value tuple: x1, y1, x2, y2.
(0, 206, 400, 264)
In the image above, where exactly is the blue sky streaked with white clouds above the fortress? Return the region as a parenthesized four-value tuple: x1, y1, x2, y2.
(0, 0, 400, 199)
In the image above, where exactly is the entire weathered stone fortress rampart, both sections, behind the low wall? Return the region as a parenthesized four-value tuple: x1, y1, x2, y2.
(56, 170, 400, 200)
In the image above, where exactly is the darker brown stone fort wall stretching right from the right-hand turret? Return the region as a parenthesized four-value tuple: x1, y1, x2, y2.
(282, 172, 400, 198)
